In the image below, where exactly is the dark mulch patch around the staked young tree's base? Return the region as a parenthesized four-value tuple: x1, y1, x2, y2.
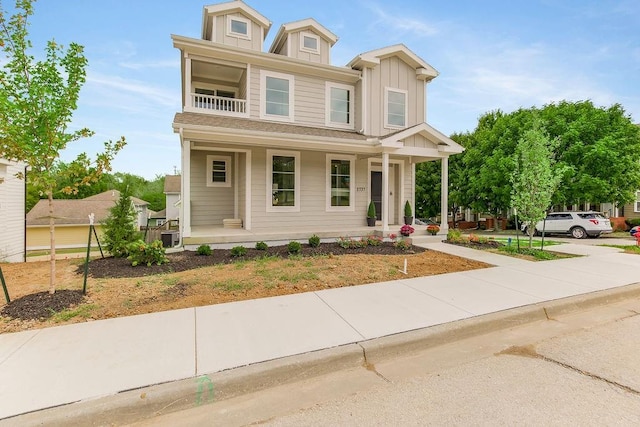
(0, 289, 84, 320)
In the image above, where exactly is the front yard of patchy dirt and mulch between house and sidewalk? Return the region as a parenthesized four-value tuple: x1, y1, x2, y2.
(0, 243, 488, 333)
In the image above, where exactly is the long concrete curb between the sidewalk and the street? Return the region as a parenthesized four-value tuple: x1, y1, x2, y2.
(5, 283, 640, 426)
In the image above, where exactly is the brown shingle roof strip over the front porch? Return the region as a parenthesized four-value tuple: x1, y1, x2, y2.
(173, 113, 367, 141)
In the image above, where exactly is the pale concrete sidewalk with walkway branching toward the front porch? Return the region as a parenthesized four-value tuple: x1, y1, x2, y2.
(0, 242, 640, 422)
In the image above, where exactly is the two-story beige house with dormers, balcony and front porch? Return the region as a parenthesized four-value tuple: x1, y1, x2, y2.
(172, 1, 463, 246)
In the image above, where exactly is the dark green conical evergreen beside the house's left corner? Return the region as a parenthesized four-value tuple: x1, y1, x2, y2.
(102, 189, 140, 257)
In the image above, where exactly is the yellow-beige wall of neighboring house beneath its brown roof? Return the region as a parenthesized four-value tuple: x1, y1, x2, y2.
(27, 225, 102, 251)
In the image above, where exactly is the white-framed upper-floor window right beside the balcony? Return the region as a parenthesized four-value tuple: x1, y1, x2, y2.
(260, 70, 294, 122)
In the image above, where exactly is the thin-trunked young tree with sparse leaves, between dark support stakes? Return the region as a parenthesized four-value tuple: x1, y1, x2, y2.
(0, 0, 125, 293)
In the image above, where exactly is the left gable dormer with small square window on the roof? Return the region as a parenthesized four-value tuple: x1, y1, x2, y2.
(202, 0, 271, 52)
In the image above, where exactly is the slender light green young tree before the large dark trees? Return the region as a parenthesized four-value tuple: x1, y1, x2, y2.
(511, 121, 560, 248)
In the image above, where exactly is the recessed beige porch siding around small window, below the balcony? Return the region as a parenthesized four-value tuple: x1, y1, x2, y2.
(190, 151, 235, 226)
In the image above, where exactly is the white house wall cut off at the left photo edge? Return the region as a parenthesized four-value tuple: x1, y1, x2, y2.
(0, 158, 25, 262)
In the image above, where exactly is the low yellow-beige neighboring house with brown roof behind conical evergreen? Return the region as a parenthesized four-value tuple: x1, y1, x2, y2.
(27, 190, 148, 251)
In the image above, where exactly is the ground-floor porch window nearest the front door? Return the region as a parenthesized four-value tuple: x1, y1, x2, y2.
(327, 154, 355, 211)
